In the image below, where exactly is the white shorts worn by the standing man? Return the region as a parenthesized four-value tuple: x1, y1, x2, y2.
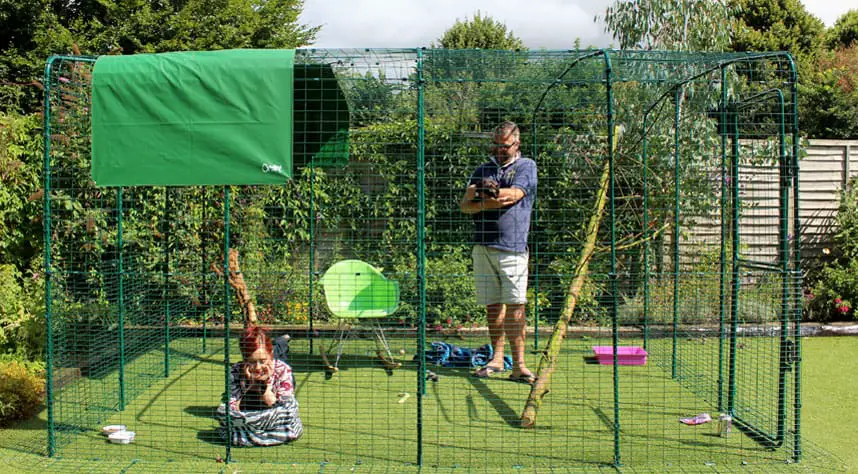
(472, 245, 528, 306)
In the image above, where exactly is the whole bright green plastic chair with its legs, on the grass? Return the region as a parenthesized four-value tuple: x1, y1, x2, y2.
(319, 260, 402, 372)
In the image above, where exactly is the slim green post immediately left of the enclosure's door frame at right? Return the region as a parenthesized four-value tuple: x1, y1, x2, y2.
(717, 67, 727, 411)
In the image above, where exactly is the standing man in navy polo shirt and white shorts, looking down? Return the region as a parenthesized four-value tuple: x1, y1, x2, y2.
(459, 122, 536, 384)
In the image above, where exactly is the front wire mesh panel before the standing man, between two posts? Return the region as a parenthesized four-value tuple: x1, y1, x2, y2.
(424, 50, 614, 468)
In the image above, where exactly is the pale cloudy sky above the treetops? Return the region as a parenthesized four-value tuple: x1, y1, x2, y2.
(300, 0, 858, 49)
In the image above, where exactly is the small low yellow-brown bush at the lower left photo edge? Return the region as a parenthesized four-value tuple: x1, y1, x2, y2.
(0, 360, 45, 426)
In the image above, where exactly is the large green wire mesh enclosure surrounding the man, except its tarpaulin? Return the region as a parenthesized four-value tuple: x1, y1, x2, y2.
(35, 49, 802, 472)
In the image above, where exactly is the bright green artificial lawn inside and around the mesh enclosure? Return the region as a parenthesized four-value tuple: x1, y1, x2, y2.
(0, 338, 858, 472)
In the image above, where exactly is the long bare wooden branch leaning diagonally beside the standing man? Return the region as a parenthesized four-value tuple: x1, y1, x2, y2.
(521, 129, 622, 428)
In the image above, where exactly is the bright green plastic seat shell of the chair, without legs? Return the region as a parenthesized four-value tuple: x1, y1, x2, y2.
(321, 260, 399, 318)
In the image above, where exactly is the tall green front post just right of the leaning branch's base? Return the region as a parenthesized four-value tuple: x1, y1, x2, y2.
(605, 53, 622, 467)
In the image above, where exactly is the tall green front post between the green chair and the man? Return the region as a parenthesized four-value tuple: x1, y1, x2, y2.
(417, 48, 426, 467)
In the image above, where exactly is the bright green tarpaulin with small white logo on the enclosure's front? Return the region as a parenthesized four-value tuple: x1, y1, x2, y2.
(92, 50, 295, 186)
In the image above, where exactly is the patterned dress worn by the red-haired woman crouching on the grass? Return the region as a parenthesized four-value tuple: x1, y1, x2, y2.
(217, 359, 304, 446)
